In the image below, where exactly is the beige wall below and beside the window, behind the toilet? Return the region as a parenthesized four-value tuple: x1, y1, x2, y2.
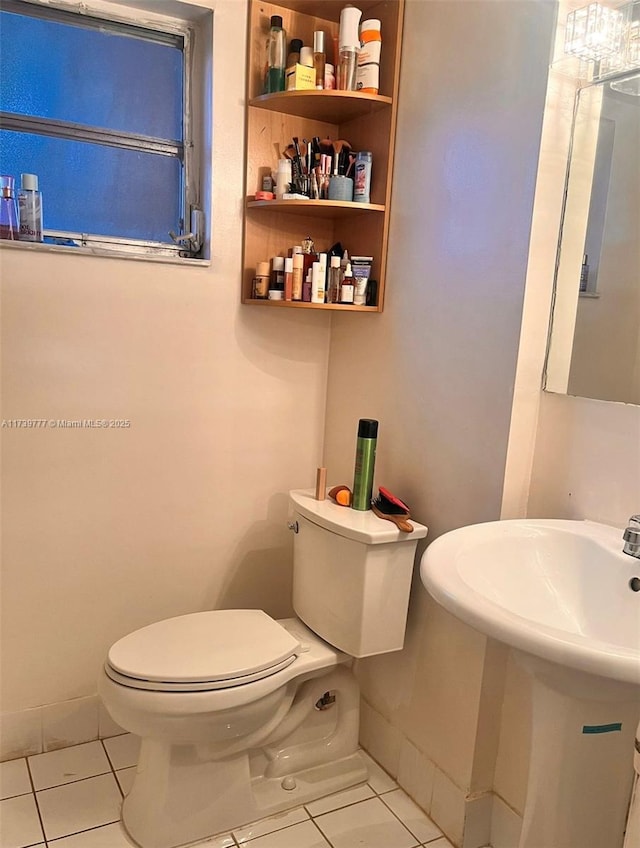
(0, 0, 329, 711)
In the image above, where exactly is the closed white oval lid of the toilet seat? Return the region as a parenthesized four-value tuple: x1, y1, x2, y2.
(107, 610, 300, 688)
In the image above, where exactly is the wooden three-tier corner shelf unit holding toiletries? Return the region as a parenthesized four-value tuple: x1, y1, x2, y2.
(242, 0, 404, 312)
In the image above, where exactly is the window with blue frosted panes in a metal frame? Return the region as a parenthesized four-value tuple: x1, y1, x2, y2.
(0, 0, 202, 256)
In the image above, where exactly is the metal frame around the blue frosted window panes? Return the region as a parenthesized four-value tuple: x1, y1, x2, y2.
(0, 0, 211, 264)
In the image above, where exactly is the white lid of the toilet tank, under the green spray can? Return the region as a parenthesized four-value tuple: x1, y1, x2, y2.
(289, 489, 427, 545)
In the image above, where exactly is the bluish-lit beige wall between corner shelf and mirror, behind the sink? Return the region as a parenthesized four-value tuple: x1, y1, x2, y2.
(325, 0, 554, 844)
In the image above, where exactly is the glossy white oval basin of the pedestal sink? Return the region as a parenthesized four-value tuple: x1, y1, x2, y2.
(420, 519, 640, 685)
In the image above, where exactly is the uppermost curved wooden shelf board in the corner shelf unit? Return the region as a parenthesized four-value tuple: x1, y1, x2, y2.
(249, 89, 392, 124)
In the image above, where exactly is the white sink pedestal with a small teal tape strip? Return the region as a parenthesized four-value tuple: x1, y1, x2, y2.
(514, 650, 640, 848)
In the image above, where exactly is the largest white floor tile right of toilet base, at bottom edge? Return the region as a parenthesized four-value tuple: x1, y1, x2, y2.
(314, 798, 418, 848)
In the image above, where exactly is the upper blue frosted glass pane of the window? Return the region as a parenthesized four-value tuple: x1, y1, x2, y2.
(0, 11, 182, 139)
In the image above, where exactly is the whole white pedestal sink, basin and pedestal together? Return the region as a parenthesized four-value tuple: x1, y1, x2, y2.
(420, 519, 640, 848)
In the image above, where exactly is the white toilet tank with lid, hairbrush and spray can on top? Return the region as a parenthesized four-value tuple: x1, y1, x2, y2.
(290, 489, 427, 657)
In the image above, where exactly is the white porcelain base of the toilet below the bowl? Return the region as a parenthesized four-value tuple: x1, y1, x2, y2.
(122, 665, 367, 848)
